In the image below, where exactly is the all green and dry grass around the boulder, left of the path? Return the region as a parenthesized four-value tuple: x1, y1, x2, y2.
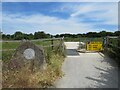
(2, 41, 65, 88)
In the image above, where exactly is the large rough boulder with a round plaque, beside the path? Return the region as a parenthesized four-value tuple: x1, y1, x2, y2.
(10, 41, 45, 69)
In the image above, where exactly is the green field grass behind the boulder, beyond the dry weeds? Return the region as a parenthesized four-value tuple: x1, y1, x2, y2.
(2, 40, 63, 62)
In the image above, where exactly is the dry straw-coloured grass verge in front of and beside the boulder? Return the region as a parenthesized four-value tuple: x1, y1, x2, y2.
(3, 54, 64, 88)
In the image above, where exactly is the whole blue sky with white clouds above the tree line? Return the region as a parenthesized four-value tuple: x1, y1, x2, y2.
(2, 2, 118, 34)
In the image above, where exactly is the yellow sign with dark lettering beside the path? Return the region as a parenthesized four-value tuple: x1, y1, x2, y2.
(86, 42, 103, 51)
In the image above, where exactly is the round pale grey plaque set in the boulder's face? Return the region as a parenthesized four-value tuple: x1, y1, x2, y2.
(23, 48, 35, 59)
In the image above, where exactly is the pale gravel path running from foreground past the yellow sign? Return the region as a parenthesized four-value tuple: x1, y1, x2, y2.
(55, 42, 118, 88)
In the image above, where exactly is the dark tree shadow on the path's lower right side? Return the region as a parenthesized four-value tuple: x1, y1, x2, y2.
(86, 58, 119, 88)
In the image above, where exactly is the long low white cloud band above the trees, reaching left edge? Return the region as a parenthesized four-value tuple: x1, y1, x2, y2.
(3, 14, 96, 34)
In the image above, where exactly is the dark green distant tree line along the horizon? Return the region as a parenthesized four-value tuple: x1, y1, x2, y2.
(2, 31, 120, 40)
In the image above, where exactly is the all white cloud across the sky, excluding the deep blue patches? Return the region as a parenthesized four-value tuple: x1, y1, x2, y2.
(3, 3, 118, 34)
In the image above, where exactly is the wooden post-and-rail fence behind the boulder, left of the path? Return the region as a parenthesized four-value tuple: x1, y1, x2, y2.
(0, 38, 65, 60)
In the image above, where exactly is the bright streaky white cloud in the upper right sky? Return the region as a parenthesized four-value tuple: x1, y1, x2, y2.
(71, 3, 118, 25)
